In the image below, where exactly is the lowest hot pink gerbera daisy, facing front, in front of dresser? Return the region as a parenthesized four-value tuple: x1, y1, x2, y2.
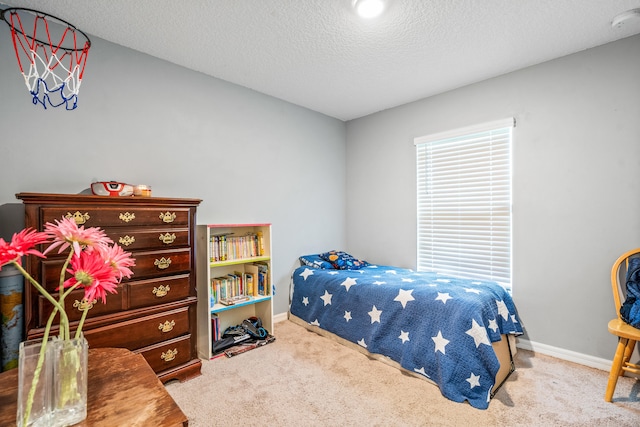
(63, 251, 119, 304)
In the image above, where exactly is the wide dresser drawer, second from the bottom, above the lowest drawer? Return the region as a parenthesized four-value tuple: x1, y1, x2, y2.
(84, 307, 189, 350)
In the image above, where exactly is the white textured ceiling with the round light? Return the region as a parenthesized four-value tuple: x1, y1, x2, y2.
(0, 0, 640, 121)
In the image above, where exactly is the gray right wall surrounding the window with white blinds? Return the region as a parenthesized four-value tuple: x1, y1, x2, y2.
(347, 36, 640, 359)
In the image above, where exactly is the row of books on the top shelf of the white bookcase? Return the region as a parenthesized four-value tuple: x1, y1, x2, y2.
(209, 231, 265, 262)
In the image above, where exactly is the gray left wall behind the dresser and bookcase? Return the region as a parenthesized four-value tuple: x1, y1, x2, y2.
(0, 25, 346, 313)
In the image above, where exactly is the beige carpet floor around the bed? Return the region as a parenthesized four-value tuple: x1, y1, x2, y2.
(166, 321, 640, 427)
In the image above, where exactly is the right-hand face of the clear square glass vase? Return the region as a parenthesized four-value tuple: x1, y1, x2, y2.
(48, 335, 89, 427)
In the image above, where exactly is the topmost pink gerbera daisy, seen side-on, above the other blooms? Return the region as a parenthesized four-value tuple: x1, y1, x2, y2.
(44, 218, 113, 256)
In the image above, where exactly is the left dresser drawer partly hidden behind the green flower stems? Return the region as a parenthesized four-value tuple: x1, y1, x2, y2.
(37, 284, 125, 327)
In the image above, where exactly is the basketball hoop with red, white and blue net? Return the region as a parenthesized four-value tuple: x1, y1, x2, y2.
(0, 7, 91, 110)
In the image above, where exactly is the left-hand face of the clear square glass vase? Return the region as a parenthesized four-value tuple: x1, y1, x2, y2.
(16, 340, 52, 427)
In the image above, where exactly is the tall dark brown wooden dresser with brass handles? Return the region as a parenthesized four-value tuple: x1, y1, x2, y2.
(16, 193, 201, 382)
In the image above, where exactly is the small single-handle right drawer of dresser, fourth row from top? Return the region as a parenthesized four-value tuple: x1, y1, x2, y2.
(127, 274, 191, 309)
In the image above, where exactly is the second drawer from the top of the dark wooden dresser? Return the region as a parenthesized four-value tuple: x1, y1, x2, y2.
(105, 227, 191, 252)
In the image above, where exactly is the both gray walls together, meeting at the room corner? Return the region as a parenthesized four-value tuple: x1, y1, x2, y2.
(0, 15, 640, 366)
